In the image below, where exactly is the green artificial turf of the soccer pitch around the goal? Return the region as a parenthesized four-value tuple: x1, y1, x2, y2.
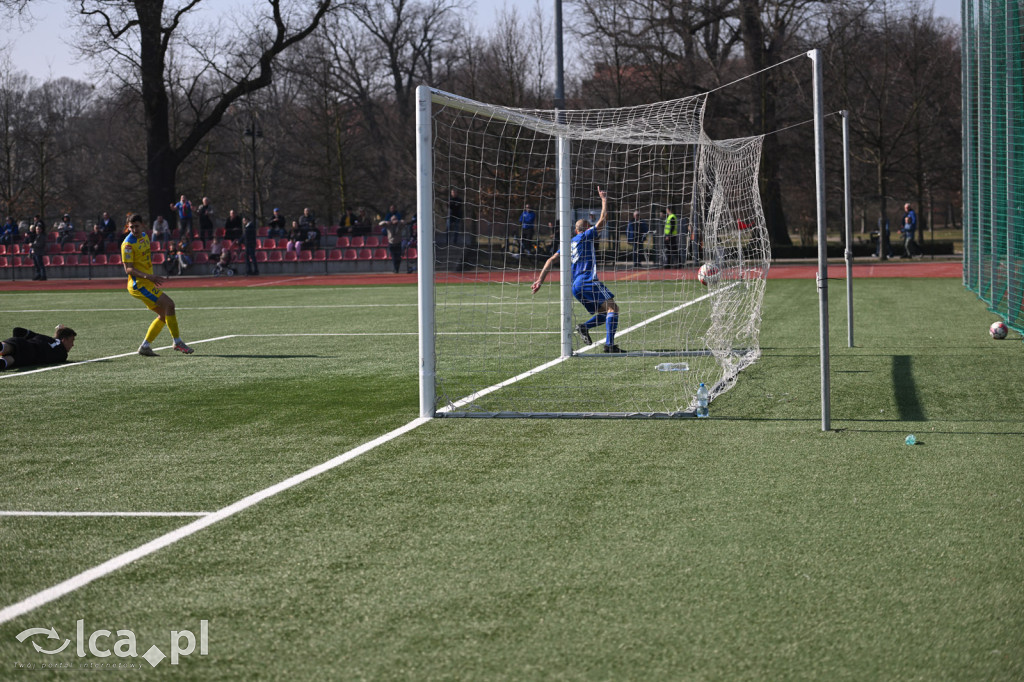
(0, 280, 1024, 680)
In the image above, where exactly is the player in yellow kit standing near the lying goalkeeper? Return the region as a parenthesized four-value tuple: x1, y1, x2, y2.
(121, 213, 194, 355)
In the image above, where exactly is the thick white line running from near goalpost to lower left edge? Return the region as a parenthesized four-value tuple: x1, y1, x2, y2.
(0, 417, 431, 624)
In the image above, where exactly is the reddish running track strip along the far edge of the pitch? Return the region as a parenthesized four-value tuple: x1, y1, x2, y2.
(0, 261, 963, 292)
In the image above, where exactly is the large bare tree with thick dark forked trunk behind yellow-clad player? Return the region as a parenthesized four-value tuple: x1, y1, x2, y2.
(50, 0, 337, 220)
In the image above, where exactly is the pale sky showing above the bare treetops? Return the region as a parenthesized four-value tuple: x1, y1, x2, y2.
(0, 0, 961, 81)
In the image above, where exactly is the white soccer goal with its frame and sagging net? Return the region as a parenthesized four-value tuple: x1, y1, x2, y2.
(417, 87, 770, 418)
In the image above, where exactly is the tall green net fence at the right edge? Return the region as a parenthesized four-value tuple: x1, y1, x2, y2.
(963, 0, 1024, 332)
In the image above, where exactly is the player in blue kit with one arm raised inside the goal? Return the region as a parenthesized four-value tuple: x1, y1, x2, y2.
(532, 187, 626, 353)
